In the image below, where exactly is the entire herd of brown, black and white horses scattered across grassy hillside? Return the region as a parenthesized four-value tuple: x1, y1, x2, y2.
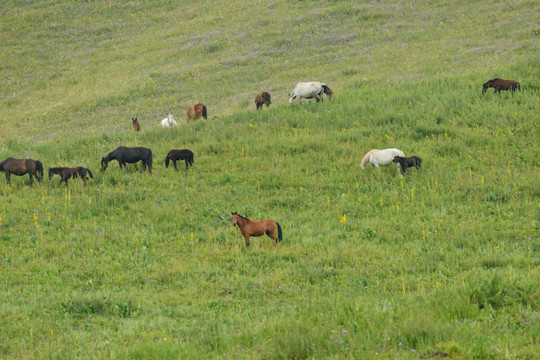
(0, 78, 521, 246)
